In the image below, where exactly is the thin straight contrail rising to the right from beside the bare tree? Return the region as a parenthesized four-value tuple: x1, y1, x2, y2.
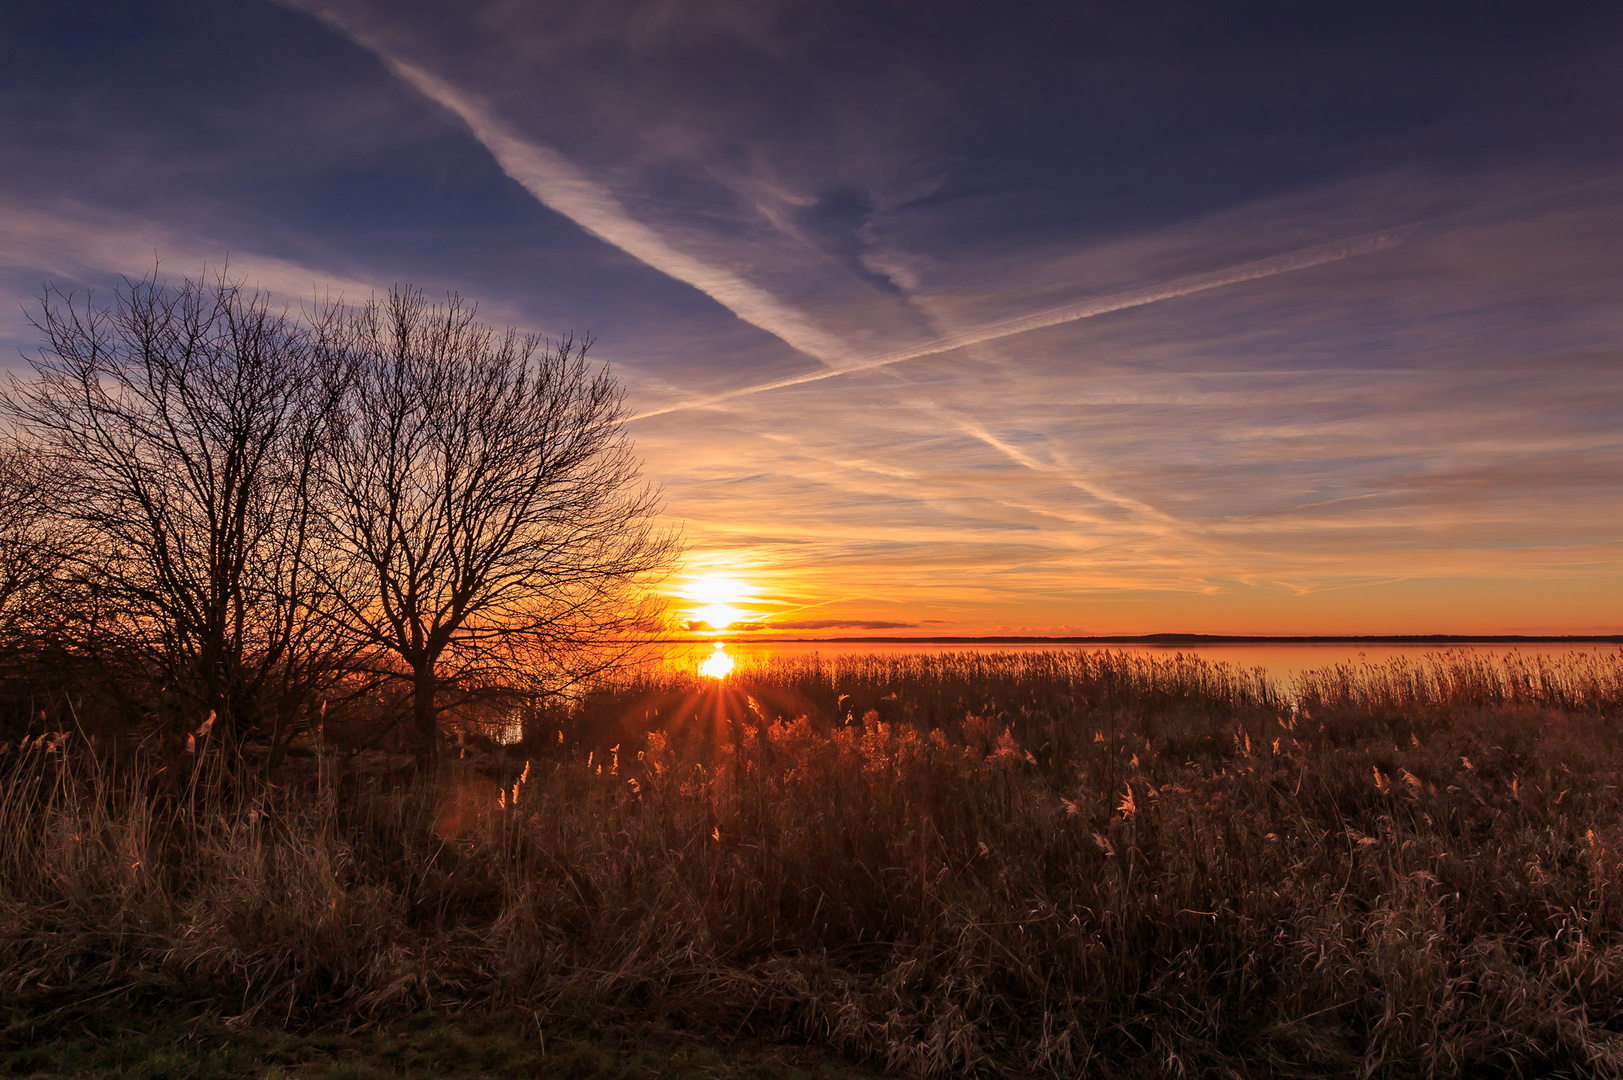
(630, 229, 1404, 421)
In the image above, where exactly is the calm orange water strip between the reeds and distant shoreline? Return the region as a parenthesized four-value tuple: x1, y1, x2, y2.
(664, 642, 1620, 685)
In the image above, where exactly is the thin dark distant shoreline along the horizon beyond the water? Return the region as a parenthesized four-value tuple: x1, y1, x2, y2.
(651, 630, 1623, 645)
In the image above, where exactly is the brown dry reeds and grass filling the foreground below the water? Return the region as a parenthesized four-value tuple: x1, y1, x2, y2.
(0, 653, 1623, 1077)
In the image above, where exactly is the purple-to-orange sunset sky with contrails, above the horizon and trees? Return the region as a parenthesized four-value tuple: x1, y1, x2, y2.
(0, 0, 1623, 637)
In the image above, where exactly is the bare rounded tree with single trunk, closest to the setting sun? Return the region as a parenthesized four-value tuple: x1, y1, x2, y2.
(323, 282, 678, 762)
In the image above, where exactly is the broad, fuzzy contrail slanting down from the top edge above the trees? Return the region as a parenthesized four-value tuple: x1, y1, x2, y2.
(284, 0, 850, 364)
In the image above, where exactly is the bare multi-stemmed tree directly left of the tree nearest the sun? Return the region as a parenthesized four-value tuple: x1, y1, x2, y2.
(5, 273, 342, 755)
